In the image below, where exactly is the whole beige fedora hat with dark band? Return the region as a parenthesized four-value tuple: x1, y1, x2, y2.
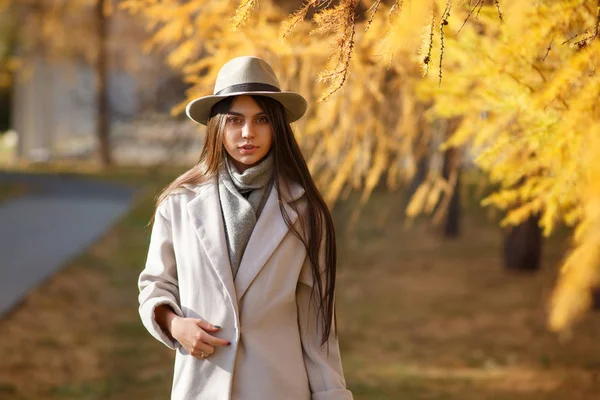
(185, 56, 307, 125)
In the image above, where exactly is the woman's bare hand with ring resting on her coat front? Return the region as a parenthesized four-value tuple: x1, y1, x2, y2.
(171, 316, 231, 359)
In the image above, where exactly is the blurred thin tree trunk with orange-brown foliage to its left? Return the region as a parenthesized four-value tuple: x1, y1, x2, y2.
(0, 0, 123, 166)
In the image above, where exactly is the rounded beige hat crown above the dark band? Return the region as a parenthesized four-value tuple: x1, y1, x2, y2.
(213, 56, 279, 94)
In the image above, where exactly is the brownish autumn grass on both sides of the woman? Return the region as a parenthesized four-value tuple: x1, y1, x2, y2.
(0, 170, 600, 400)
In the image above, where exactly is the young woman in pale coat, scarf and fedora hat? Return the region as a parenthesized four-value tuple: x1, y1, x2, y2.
(138, 57, 352, 400)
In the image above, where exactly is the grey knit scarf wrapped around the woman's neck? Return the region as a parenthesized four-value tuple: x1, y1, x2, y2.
(217, 154, 273, 277)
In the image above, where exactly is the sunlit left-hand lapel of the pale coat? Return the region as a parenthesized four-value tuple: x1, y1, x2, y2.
(184, 178, 238, 313)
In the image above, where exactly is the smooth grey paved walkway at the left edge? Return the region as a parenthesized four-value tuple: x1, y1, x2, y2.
(0, 171, 133, 316)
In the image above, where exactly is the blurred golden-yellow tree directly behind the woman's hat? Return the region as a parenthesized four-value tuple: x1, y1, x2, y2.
(120, 0, 436, 216)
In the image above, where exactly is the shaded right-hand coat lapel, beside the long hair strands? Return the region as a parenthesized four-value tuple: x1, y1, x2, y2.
(232, 182, 304, 301)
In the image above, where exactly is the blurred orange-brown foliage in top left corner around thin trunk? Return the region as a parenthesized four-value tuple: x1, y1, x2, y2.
(0, 0, 149, 84)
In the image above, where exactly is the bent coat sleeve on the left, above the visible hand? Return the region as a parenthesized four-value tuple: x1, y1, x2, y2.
(138, 201, 183, 350)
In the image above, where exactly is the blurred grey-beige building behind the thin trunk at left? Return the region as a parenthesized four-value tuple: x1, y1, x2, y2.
(3, 4, 202, 165)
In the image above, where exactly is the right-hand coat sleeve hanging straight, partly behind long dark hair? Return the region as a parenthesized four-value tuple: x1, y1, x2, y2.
(296, 247, 352, 400)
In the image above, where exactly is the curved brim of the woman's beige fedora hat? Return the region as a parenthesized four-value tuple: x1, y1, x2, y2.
(185, 92, 308, 125)
